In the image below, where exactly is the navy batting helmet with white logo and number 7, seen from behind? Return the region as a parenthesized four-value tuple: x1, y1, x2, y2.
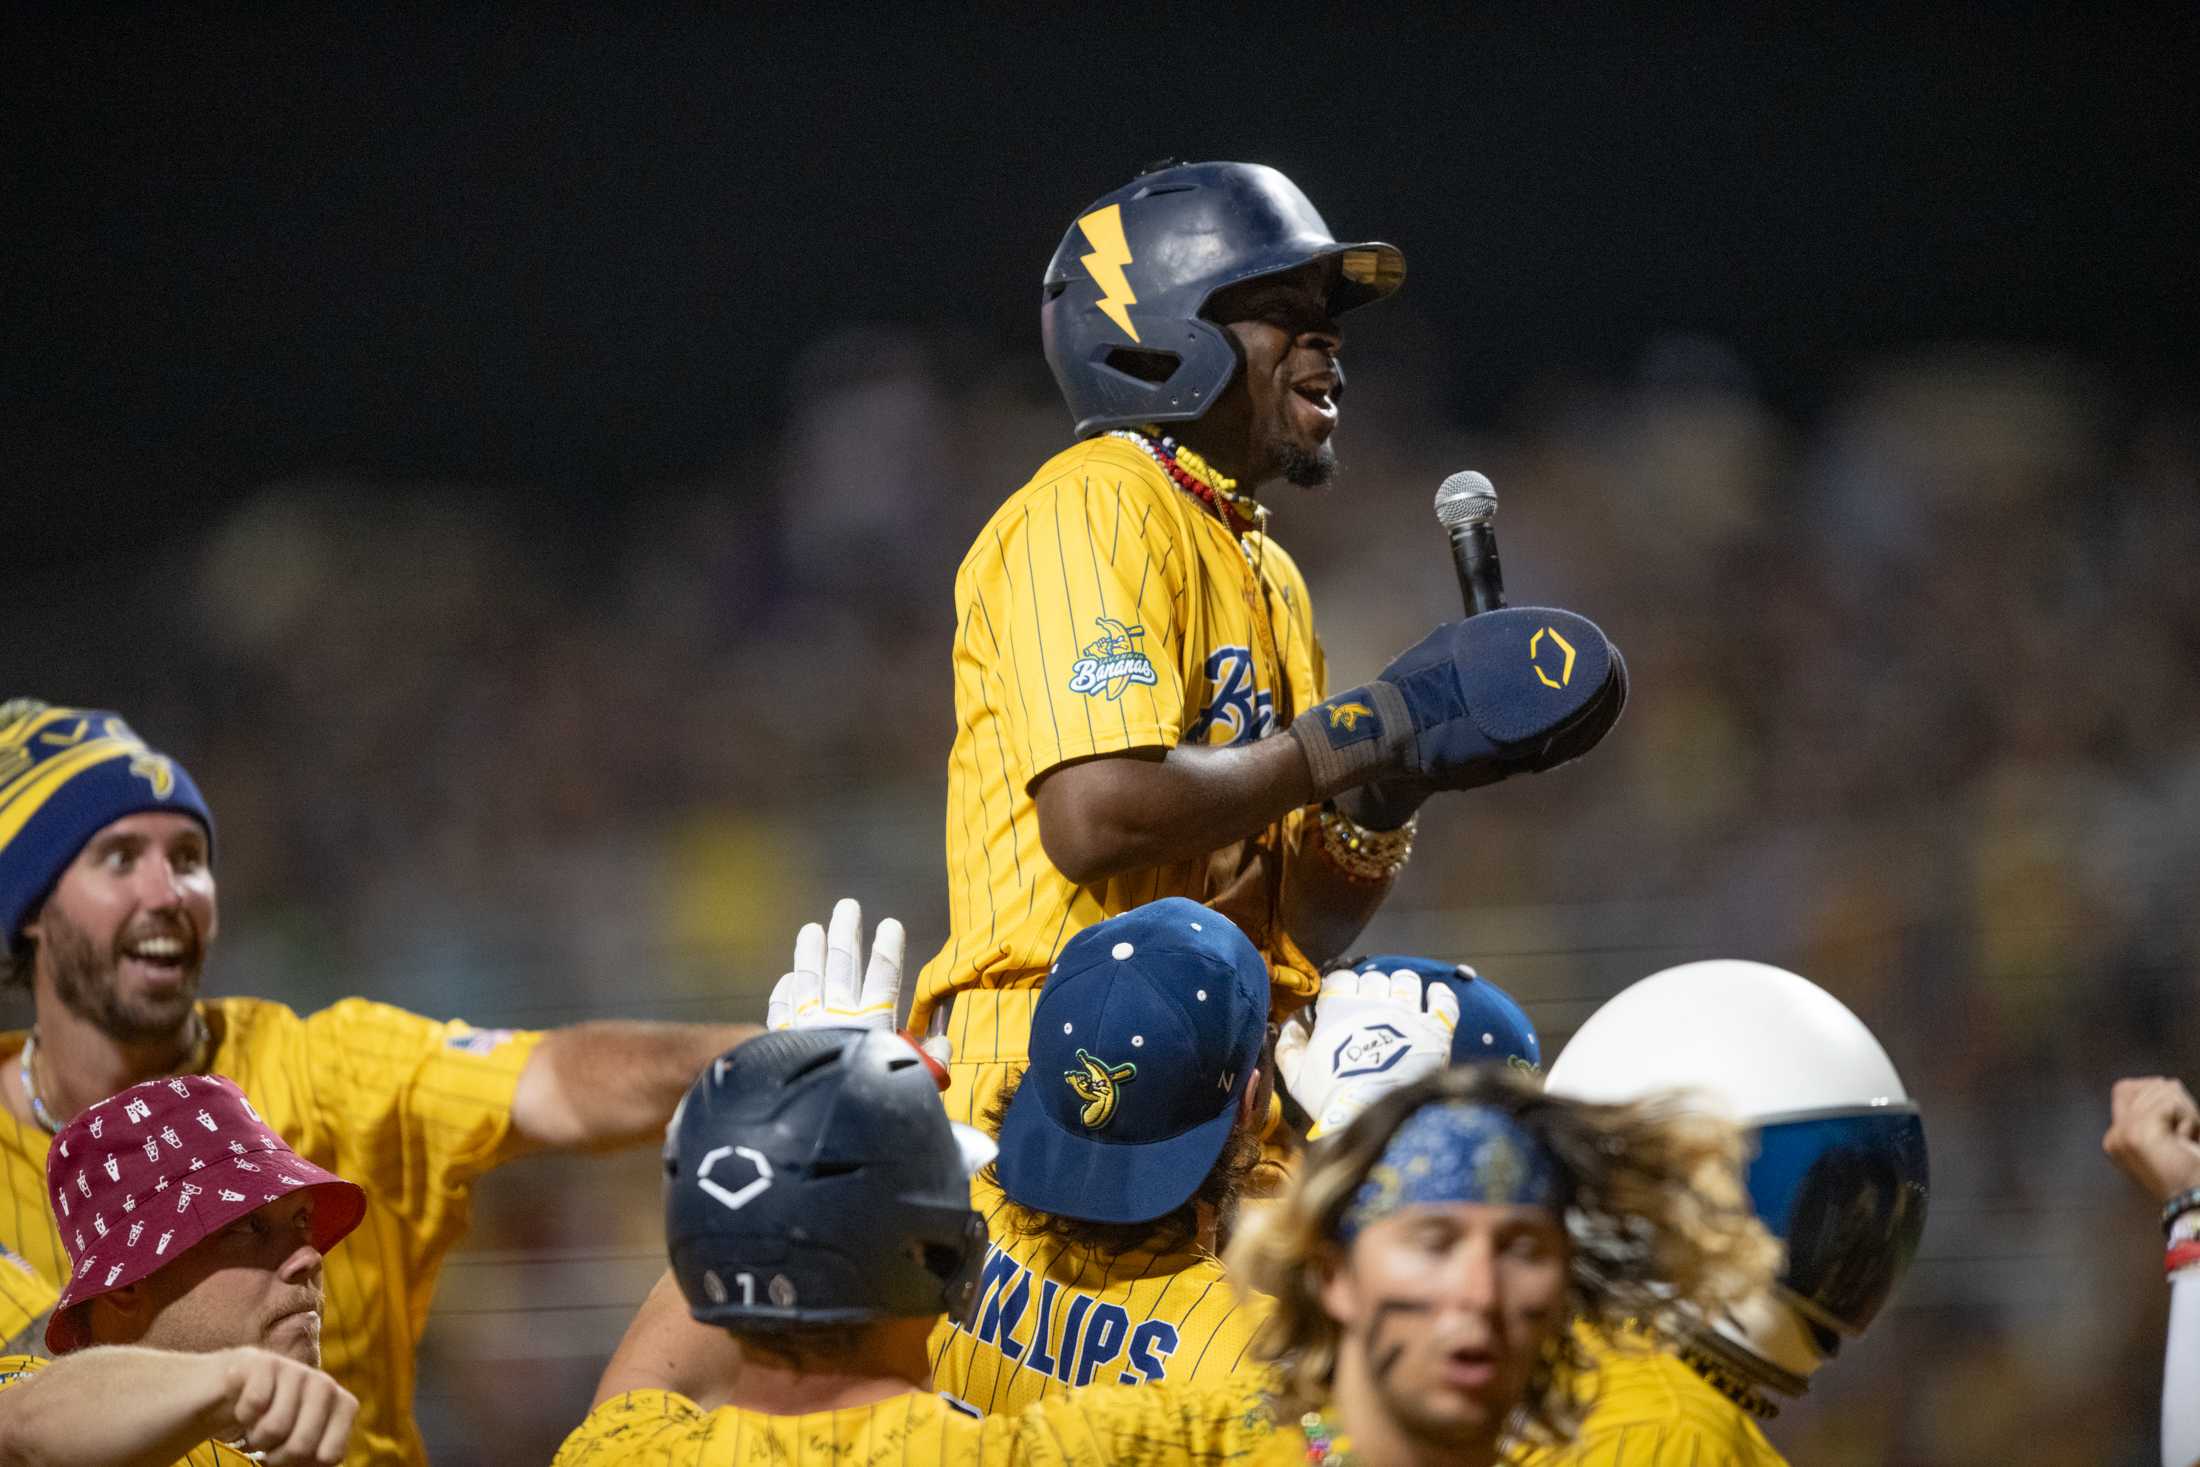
(664, 1029, 992, 1333)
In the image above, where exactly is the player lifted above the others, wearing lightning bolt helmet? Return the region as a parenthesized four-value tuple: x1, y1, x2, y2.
(913, 163, 1626, 1119)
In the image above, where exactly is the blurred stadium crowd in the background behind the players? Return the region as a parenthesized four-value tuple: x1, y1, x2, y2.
(0, 332, 2200, 1467)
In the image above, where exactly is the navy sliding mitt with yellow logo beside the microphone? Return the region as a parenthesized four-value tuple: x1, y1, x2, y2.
(1289, 607, 1628, 820)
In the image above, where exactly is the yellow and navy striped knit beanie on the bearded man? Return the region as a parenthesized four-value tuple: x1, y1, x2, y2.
(0, 697, 213, 952)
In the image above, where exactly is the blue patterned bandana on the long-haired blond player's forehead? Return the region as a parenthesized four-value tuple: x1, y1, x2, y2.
(1338, 1100, 1569, 1243)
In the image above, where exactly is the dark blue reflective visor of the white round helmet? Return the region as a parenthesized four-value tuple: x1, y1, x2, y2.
(1749, 1104, 1927, 1335)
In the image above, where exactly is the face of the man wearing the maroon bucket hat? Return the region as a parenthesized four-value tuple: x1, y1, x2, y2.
(141, 1188, 321, 1366)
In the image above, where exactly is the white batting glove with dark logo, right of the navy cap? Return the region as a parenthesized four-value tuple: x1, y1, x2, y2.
(1276, 970, 1459, 1141)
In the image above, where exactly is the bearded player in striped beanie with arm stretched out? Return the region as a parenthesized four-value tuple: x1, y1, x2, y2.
(0, 699, 755, 1463)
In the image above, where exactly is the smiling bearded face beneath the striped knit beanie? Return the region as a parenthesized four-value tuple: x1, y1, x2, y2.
(24, 812, 216, 1043)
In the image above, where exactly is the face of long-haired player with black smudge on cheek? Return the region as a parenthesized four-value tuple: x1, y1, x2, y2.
(1322, 1203, 1569, 1449)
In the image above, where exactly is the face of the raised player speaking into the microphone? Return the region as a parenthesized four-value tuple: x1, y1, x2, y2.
(1208, 262, 1344, 488)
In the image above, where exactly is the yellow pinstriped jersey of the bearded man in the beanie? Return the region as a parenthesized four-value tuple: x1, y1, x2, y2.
(0, 999, 541, 1463)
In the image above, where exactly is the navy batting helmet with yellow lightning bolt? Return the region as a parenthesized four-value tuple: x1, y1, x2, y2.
(1038, 163, 1406, 438)
